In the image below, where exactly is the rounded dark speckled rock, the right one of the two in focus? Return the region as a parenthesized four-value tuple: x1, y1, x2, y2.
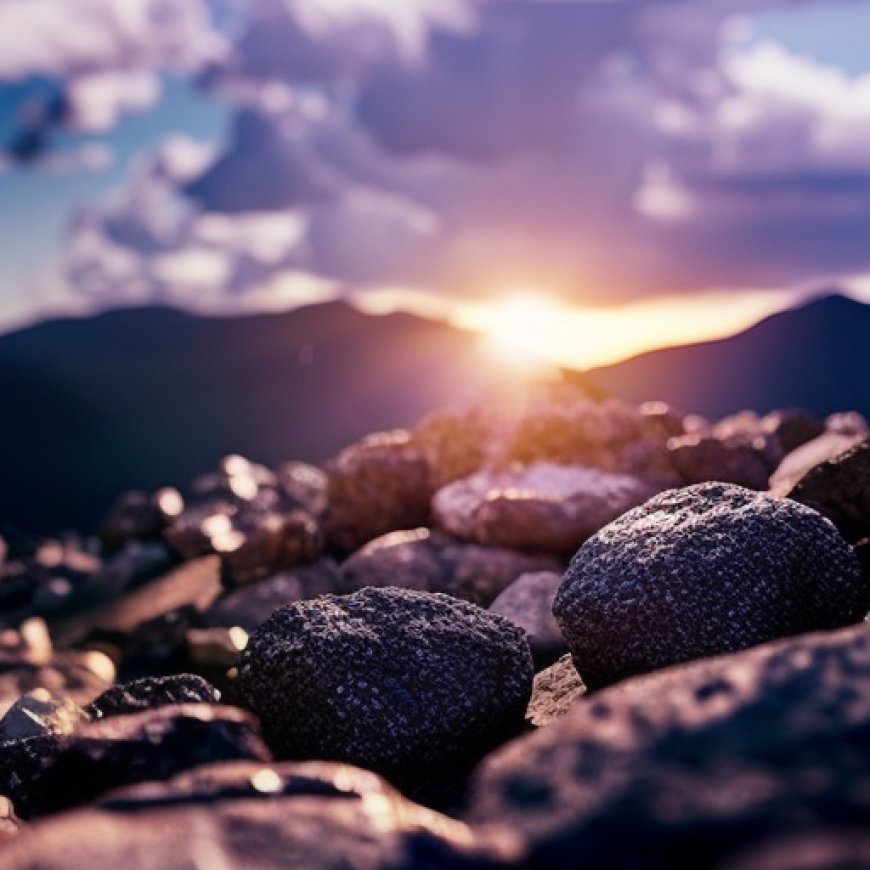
(553, 483, 870, 689)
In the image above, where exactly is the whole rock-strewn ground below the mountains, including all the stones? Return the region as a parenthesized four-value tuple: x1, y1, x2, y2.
(0, 386, 870, 870)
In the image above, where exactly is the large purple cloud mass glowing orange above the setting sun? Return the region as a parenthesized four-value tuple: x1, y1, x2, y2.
(49, 0, 870, 316)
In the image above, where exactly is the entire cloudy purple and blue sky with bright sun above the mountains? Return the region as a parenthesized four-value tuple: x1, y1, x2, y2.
(0, 0, 870, 367)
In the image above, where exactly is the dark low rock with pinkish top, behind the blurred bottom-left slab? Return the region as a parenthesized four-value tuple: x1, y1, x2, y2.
(0, 704, 270, 819)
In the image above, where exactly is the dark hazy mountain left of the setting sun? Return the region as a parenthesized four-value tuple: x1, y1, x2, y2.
(0, 302, 540, 532)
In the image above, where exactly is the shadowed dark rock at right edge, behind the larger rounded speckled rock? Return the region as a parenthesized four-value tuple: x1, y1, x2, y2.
(788, 441, 870, 544)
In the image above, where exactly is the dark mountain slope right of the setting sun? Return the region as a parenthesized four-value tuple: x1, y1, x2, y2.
(586, 295, 870, 417)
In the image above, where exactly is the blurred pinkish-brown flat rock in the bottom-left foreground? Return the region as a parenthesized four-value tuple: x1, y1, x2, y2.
(2, 762, 521, 870)
